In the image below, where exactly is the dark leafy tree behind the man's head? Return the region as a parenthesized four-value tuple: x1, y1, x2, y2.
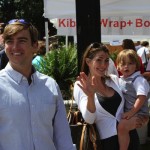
(0, 0, 55, 39)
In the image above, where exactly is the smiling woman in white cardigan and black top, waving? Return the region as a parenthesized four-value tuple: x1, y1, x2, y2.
(73, 43, 141, 150)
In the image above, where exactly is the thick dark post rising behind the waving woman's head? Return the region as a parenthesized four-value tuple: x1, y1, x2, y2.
(76, 0, 101, 72)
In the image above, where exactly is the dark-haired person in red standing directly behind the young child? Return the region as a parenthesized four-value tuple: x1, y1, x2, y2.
(119, 39, 144, 75)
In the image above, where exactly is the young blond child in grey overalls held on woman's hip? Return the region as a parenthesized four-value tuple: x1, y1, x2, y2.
(117, 49, 150, 150)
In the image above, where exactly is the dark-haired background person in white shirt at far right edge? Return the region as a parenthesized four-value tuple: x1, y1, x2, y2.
(137, 41, 150, 71)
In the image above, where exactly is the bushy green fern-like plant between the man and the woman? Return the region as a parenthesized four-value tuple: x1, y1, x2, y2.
(37, 45, 78, 99)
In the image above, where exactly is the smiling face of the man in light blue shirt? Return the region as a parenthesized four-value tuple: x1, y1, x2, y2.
(5, 30, 38, 69)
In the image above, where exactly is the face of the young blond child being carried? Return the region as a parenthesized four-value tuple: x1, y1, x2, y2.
(119, 58, 136, 78)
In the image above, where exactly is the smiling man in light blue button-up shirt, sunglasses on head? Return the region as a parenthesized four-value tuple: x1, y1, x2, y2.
(0, 19, 73, 150)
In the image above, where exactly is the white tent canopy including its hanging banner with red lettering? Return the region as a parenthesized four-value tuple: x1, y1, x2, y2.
(44, 0, 150, 41)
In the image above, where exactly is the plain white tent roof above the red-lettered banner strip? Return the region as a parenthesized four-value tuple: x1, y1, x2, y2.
(44, 0, 150, 19)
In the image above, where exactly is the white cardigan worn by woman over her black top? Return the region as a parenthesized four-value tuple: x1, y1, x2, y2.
(74, 75, 124, 139)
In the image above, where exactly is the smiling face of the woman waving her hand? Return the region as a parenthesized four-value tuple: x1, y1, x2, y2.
(86, 51, 109, 77)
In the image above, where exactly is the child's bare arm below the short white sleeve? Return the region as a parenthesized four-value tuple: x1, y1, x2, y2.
(122, 95, 146, 119)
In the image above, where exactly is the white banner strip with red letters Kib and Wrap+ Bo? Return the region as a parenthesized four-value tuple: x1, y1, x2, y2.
(50, 16, 150, 36)
